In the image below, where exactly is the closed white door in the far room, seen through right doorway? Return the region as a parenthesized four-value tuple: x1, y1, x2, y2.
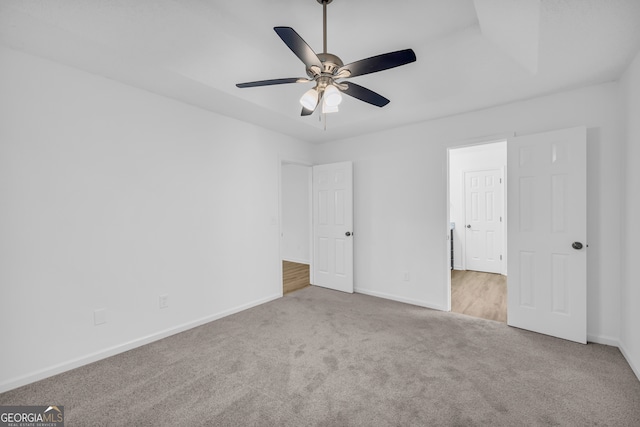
(464, 169, 504, 273)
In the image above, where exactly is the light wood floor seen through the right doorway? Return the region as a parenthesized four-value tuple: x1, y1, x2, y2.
(451, 270, 507, 323)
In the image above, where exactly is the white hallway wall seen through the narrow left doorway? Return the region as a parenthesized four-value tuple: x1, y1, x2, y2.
(281, 163, 311, 264)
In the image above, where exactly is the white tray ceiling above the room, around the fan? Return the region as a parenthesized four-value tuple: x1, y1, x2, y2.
(0, 0, 640, 142)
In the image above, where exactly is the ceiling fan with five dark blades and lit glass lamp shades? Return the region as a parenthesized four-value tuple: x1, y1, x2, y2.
(236, 0, 416, 116)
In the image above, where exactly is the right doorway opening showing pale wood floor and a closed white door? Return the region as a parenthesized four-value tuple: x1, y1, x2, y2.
(447, 141, 507, 323)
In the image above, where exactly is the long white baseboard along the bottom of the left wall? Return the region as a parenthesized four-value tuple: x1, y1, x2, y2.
(0, 293, 282, 393)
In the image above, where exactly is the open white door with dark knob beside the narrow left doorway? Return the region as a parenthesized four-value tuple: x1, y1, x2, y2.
(313, 162, 353, 293)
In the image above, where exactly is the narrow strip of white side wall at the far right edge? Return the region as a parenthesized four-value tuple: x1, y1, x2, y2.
(620, 48, 640, 378)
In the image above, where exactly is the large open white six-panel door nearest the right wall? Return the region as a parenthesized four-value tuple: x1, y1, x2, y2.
(507, 127, 587, 343)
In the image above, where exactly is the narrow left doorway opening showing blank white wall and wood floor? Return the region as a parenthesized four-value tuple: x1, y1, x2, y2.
(280, 161, 312, 295)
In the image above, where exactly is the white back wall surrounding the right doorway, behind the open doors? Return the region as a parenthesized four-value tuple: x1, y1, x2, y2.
(314, 83, 624, 344)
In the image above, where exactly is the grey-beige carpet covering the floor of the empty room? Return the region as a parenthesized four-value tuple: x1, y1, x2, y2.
(0, 286, 640, 427)
